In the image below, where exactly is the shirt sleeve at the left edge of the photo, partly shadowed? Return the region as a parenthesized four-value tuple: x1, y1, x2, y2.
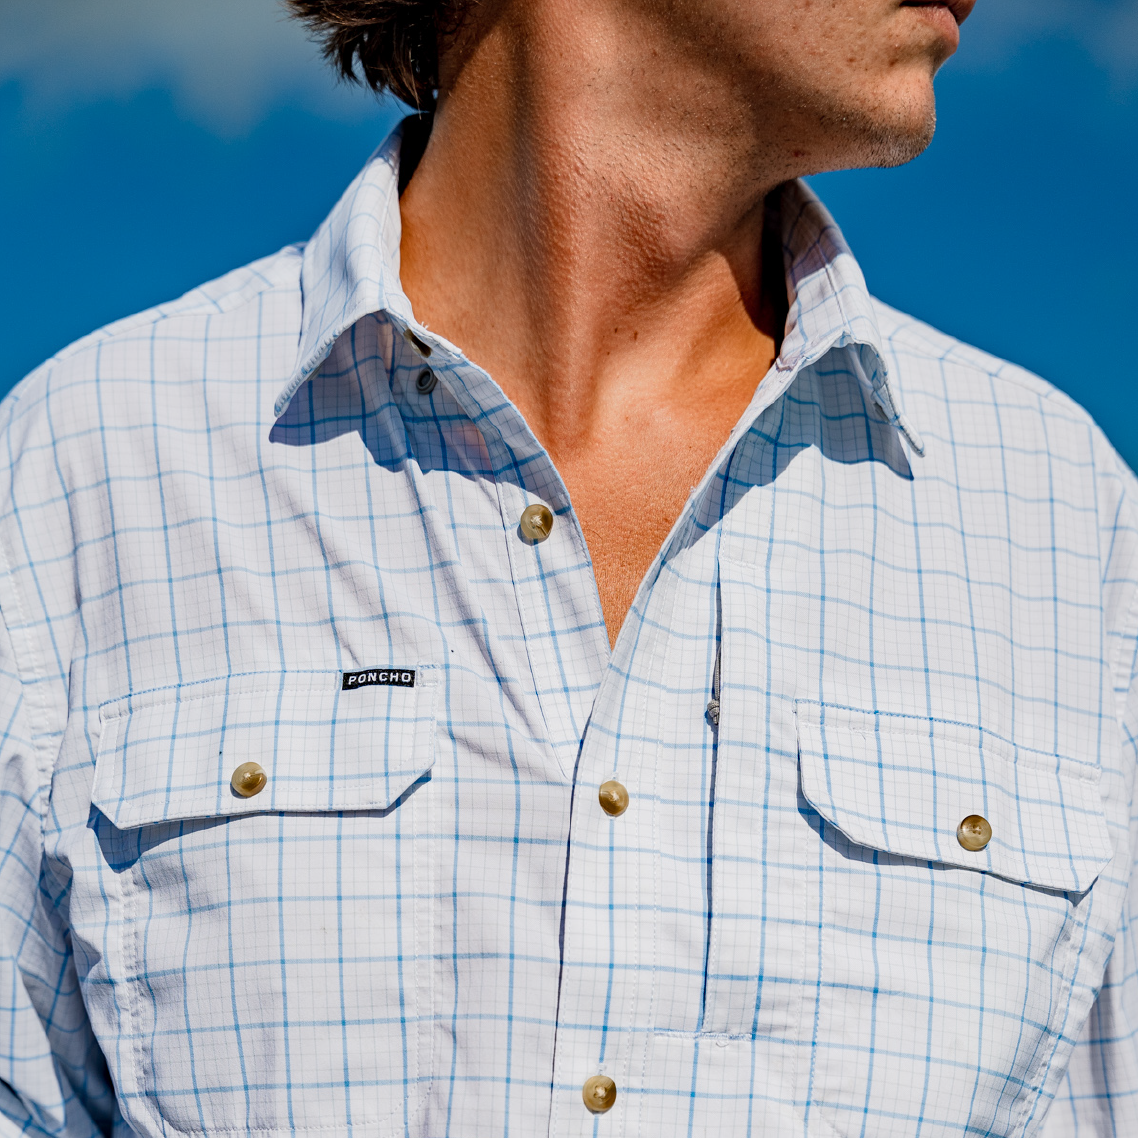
(0, 617, 116, 1138)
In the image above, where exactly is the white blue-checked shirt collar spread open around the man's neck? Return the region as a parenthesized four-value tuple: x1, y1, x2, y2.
(273, 116, 924, 454)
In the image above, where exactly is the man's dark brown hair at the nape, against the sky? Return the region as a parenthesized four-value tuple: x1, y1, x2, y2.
(287, 0, 461, 108)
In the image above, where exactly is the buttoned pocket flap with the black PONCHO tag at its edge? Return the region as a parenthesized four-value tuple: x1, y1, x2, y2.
(91, 666, 439, 830)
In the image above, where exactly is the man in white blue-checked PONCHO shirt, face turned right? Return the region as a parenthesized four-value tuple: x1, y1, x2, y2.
(0, 0, 1138, 1138)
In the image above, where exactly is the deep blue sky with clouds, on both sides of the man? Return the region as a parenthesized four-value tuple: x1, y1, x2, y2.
(0, 0, 1138, 465)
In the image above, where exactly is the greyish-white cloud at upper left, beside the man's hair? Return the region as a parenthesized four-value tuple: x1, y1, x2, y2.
(0, 0, 389, 134)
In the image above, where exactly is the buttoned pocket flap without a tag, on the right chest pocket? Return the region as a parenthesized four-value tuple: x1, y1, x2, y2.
(794, 700, 1112, 892)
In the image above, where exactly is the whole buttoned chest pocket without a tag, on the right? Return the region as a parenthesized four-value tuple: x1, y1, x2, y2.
(794, 701, 1112, 1135)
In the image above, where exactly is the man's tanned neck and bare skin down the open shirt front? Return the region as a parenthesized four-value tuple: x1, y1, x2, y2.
(401, 0, 786, 638)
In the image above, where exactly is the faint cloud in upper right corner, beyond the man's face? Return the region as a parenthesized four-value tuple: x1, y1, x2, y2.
(962, 0, 1138, 85)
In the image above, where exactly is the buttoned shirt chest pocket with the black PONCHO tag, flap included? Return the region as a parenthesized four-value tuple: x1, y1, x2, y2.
(92, 666, 439, 1136)
